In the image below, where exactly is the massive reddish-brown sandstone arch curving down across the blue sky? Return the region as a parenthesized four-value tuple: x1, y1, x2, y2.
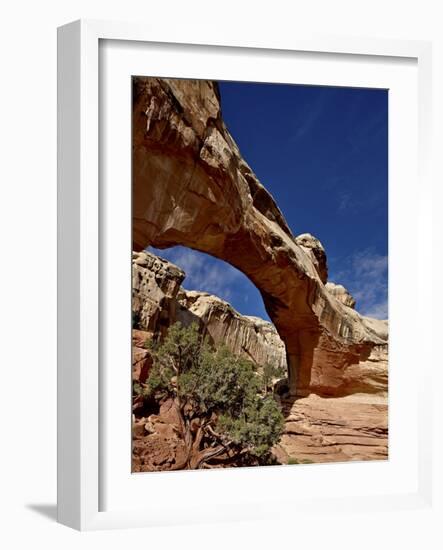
(133, 77, 387, 395)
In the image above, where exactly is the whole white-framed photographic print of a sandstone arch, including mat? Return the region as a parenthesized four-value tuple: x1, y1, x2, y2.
(58, 21, 431, 529)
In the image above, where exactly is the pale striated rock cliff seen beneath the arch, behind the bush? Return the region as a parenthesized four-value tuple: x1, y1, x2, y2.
(132, 251, 286, 380)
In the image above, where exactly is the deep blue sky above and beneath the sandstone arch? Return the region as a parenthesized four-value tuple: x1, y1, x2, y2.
(150, 82, 388, 319)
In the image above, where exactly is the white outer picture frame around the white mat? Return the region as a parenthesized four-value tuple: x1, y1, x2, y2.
(58, 21, 432, 530)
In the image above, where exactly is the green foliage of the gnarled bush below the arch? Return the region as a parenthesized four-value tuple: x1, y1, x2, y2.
(144, 323, 283, 466)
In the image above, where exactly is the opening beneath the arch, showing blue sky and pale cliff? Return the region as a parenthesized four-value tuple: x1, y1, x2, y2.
(132, 245, 288, 391)
